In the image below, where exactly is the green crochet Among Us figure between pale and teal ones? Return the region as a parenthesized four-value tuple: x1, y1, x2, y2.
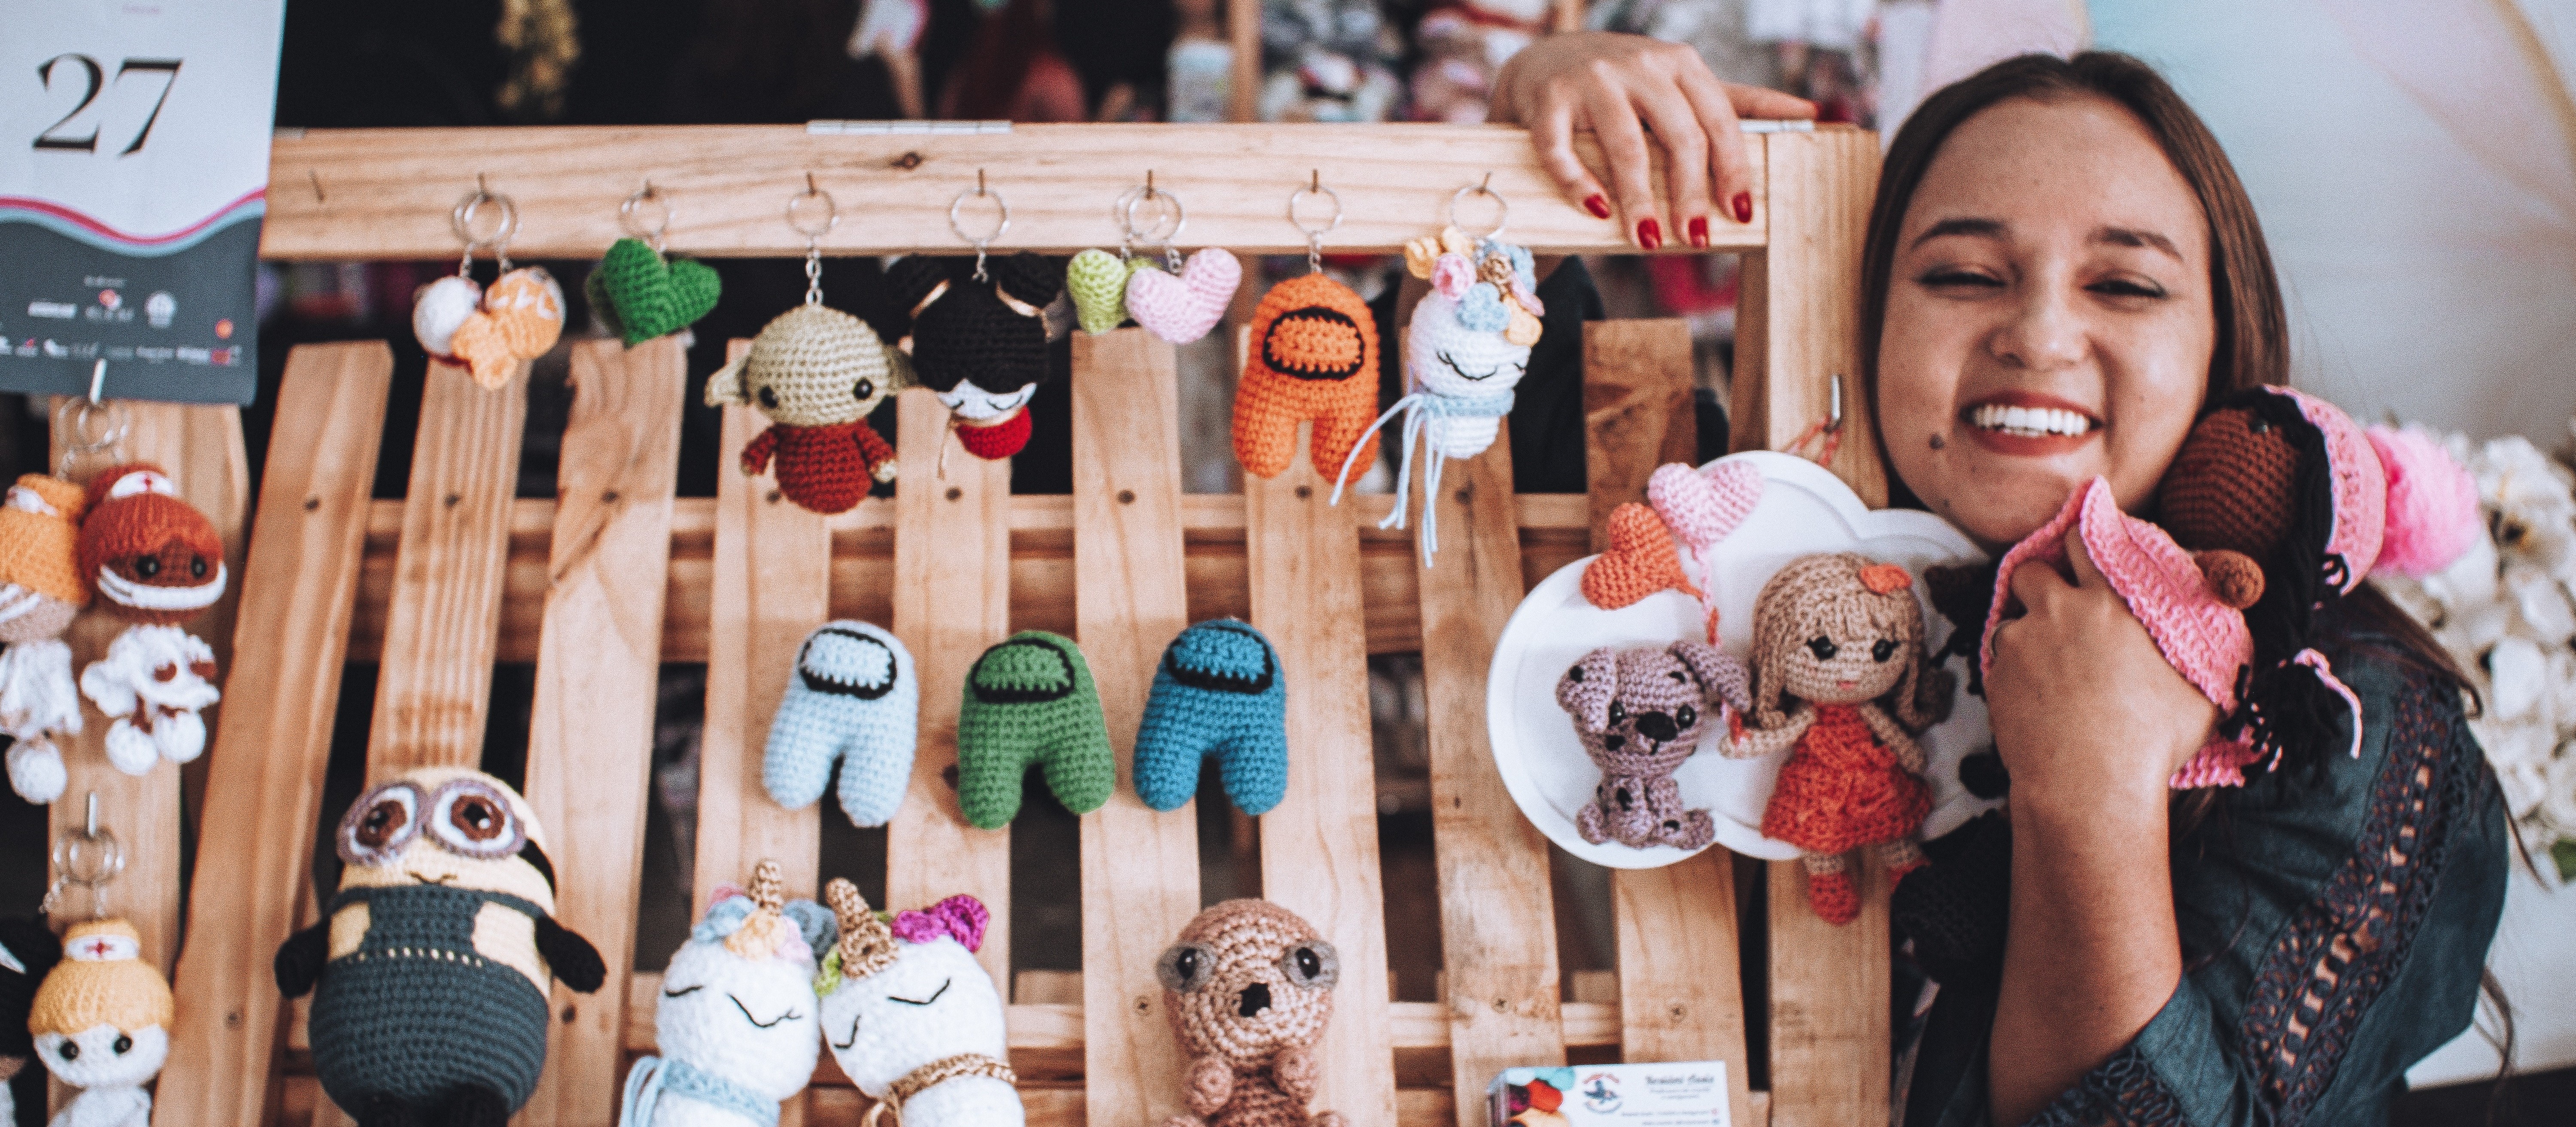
(958, 630, 1118, 829)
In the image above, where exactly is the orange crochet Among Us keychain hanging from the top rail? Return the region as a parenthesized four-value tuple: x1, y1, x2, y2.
(1234, 273, 1378, 479)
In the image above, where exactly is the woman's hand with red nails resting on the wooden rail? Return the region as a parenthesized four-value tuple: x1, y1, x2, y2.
(1494, 31, 1816, 249)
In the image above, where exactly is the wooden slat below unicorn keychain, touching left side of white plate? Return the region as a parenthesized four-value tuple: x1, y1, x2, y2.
(1414, 432, 1566, 1127)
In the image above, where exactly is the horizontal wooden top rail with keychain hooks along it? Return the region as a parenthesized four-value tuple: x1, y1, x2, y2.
(260, 121, 1814, 260)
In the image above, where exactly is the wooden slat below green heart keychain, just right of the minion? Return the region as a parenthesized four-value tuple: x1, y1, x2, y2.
(518, 337, 688, 1127)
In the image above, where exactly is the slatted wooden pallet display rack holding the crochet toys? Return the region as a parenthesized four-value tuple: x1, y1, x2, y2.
(54, 126, 1888, 1127)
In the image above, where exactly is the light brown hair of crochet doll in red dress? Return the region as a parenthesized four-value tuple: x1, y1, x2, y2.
(1749, 551, 1950, 731)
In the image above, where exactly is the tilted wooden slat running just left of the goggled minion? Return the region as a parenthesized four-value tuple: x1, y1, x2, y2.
(160, 340, 394, 1127)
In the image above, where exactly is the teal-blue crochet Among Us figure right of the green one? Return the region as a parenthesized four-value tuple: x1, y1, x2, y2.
(1136, 617, 1288, 813)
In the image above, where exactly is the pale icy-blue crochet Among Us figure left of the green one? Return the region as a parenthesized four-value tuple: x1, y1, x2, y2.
(760, 617, 922, 826)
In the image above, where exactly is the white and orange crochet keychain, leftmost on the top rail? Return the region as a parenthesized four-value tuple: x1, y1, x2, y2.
(412, 178, 564, 391)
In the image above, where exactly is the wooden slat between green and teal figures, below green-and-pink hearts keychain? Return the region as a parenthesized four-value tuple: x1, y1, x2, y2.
(1072, 329, 1198, 1124)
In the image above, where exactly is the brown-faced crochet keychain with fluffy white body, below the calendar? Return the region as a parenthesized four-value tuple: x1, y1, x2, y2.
(77, 463, 224, 775)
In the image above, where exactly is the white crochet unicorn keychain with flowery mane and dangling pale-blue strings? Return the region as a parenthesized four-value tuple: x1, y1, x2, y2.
(1332, 185, 1546, 566)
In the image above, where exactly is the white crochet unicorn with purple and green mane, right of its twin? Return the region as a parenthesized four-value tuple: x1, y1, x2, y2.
(814, 878, 1028, 1127)
